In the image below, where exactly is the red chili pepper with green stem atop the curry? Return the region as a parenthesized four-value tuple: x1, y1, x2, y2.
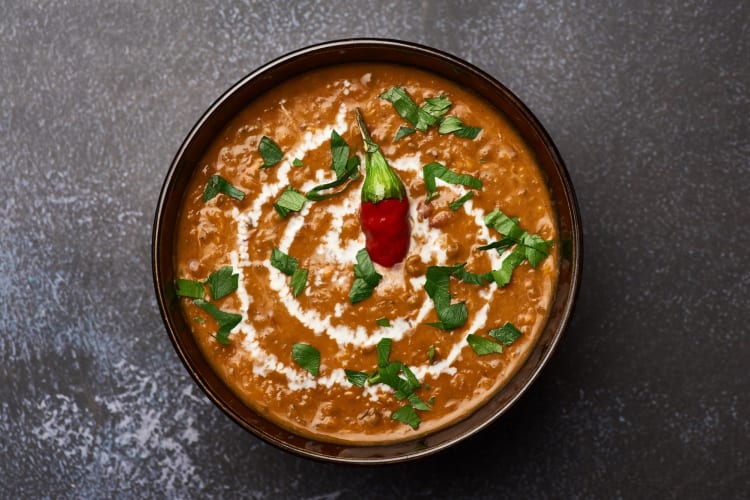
(356, 109, 411, 267)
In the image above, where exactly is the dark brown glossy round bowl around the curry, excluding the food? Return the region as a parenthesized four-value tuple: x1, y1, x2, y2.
(152, 39, 582, 464)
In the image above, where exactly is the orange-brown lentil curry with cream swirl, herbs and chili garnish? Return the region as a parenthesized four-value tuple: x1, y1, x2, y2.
(175, 64, 559, 445)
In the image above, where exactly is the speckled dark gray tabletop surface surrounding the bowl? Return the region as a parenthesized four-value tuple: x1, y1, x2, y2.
(0, 0, 750, 499)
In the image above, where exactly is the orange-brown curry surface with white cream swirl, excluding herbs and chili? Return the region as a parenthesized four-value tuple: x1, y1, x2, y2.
(176, 64, 559, 444)
